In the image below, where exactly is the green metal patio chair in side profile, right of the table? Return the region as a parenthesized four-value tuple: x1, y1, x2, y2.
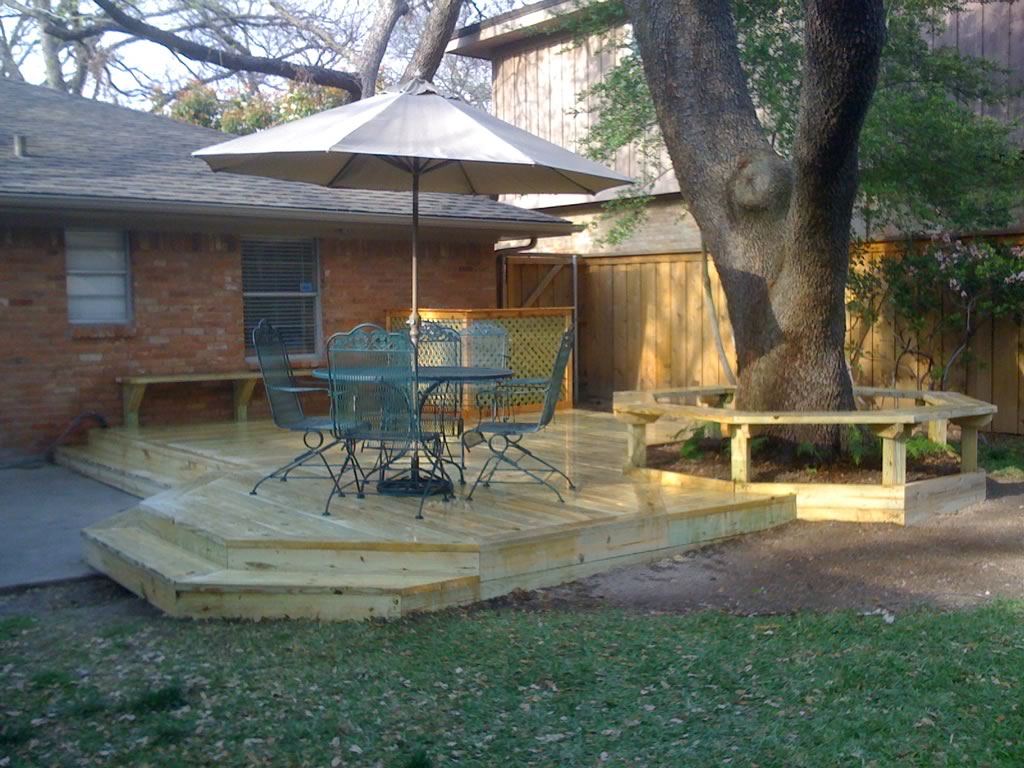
(464, 327, 575, 502)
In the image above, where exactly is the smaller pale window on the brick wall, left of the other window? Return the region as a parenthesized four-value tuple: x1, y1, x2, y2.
(65, 229, 131, 325)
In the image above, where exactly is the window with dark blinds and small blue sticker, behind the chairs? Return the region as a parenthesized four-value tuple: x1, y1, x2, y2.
(242, 239, 319, 355)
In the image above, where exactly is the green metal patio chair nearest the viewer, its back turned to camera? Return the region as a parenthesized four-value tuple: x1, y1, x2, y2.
(324, 324, 449, 518)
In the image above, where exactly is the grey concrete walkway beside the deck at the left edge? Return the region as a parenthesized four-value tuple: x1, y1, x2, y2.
(0, 465, 138, 589)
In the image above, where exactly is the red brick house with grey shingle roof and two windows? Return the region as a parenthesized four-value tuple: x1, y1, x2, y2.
(0, 80, 573, 452)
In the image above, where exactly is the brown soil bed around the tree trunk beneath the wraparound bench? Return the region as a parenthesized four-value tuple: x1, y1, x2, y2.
(647, 439, 959, 485)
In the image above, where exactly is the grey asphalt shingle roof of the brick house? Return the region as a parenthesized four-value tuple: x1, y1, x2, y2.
(0, 79, 570, 233)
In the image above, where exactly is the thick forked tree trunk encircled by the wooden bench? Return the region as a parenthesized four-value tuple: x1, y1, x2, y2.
(626, 0, 885, 444)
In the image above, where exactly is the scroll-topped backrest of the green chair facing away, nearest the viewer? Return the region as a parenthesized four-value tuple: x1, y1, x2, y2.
(327, 324, 411, 439)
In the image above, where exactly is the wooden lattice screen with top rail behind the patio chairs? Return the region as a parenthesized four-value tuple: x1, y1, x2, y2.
(387, 306, 572, 408)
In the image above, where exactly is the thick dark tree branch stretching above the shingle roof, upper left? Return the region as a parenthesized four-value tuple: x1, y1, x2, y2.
(95, 0, 361, 98)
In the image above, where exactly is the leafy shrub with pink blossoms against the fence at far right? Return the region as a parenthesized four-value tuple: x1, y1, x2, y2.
(847, 236, 1024, 389)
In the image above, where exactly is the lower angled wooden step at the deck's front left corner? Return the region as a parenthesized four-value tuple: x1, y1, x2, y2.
(83, 516, 479, 620)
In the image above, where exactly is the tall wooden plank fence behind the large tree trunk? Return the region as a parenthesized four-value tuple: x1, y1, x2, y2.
(508, 254, 1024, 434)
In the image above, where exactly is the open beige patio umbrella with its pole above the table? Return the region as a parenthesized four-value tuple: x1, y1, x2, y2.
(193, 79, 631, 343)
